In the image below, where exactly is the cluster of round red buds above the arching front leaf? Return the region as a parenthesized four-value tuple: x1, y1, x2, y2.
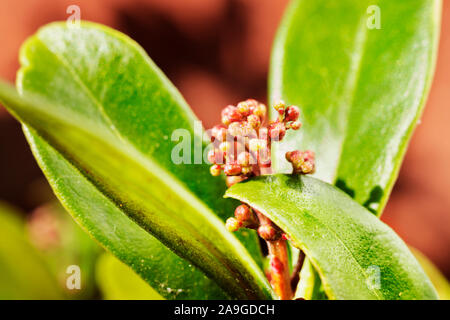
(208, 99, 314, 186)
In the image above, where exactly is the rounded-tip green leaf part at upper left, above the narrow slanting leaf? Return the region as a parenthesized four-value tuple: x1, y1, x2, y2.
(17, 22, 262, 265)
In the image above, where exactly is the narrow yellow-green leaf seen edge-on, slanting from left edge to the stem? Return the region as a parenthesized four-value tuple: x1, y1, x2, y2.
(0, 83, 273, 299)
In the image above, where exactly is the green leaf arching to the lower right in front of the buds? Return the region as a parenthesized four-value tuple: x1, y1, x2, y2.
(226, 175, 437, 299)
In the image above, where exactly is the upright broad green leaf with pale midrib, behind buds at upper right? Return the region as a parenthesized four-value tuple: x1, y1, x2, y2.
(269, 0, 441, 215)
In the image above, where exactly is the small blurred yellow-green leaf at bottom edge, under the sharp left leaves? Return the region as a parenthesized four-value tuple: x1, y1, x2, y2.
(96, 253, 163, 300)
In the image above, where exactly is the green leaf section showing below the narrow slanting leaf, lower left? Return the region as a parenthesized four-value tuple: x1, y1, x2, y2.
(25, 129, 227, 299)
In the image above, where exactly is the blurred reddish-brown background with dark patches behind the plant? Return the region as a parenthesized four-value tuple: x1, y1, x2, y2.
(0, 0, 450, 277)
